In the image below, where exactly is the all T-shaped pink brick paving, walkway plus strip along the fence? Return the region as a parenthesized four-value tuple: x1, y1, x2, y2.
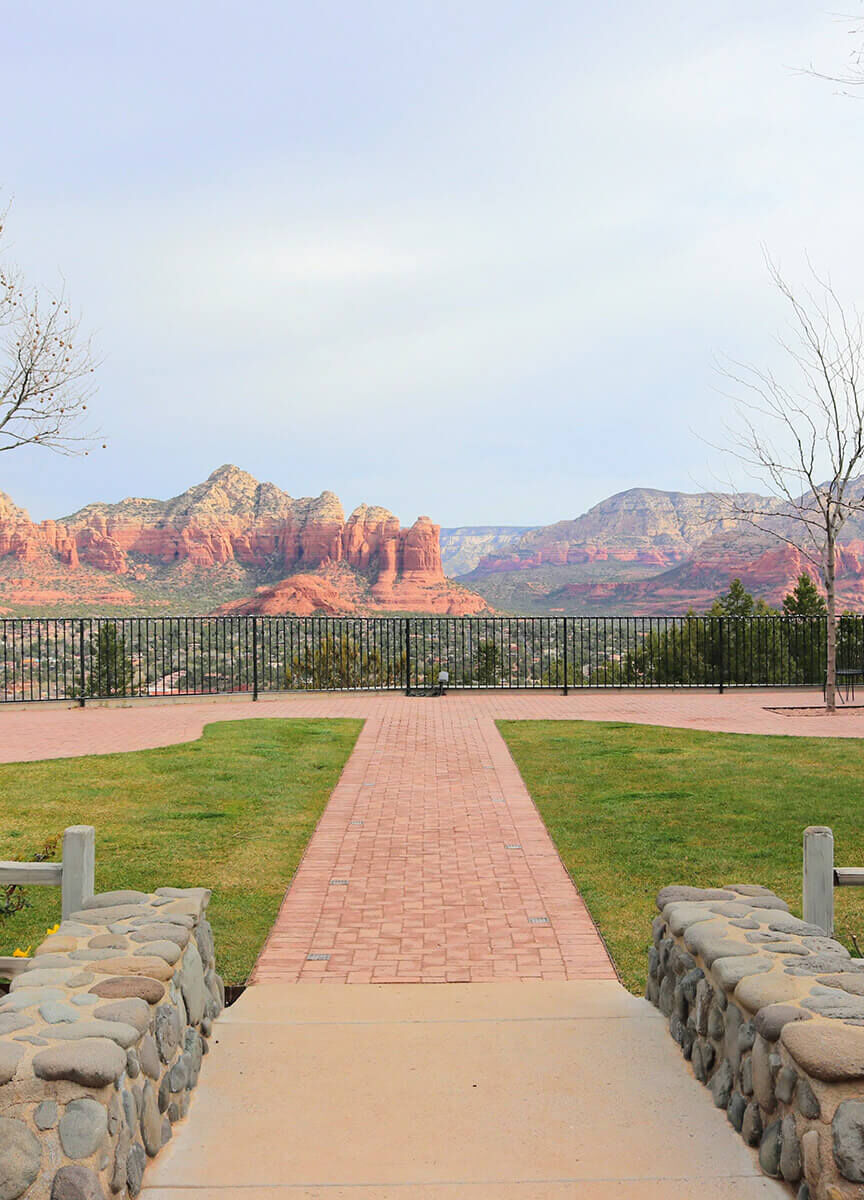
(0, 692, 864, 983)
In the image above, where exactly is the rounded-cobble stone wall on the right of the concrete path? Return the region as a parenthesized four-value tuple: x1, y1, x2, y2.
(646, 884, 864, 1200)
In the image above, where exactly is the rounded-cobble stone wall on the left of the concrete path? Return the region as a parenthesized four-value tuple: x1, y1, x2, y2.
(0, 888, 224, 1200)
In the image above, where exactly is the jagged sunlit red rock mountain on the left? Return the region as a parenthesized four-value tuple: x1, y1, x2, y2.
(0, 466, 488, 613)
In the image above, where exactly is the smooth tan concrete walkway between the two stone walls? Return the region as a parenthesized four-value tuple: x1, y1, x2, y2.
(142, 980, 790, 1200)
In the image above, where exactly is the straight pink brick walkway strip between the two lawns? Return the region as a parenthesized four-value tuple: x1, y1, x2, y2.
(253, 700, 614, 983)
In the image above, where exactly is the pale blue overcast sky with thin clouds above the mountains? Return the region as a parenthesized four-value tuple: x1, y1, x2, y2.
(0, 0, 864, 526)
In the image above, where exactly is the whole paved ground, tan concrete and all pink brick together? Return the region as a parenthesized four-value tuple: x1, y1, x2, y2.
(6, 692, 816, 1200)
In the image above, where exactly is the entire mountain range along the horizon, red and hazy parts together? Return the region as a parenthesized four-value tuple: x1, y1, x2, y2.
(0, 466, 864, 616)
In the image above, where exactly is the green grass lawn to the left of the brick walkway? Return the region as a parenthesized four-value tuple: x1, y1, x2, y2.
(0, 720, 362, 983)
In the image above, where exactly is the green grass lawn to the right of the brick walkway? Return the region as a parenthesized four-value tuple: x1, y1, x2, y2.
(498, 721, 864, 992)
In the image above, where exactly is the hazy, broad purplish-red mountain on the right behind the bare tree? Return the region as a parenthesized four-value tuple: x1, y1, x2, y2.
(460, 488, 864, 616)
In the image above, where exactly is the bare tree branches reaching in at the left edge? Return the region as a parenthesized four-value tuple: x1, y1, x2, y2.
(0, 204, 95, 454)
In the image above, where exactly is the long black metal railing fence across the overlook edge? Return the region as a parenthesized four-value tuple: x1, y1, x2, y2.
(0, 616, 864, 703)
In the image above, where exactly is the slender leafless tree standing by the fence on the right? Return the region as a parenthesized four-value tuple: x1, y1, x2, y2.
(724, 260, 864, 712)
